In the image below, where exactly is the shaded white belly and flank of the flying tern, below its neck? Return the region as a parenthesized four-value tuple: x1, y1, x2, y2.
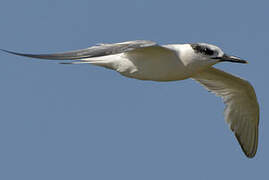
(84, 47, 195, 81)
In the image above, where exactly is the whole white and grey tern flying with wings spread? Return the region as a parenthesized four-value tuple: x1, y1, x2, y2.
(2, 40, 259, 158)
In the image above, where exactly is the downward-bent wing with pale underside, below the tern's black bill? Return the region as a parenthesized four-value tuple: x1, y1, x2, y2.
(193, 67, 259, 158)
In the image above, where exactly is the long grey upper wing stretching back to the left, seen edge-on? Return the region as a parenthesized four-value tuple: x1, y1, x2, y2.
(1, 40, 157, 60)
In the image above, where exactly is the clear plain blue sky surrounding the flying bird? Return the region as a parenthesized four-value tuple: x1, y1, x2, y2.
(0, 0, 269, 180)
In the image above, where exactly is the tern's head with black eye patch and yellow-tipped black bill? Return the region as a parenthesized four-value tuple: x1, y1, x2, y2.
(190, 43, 248, 64)
